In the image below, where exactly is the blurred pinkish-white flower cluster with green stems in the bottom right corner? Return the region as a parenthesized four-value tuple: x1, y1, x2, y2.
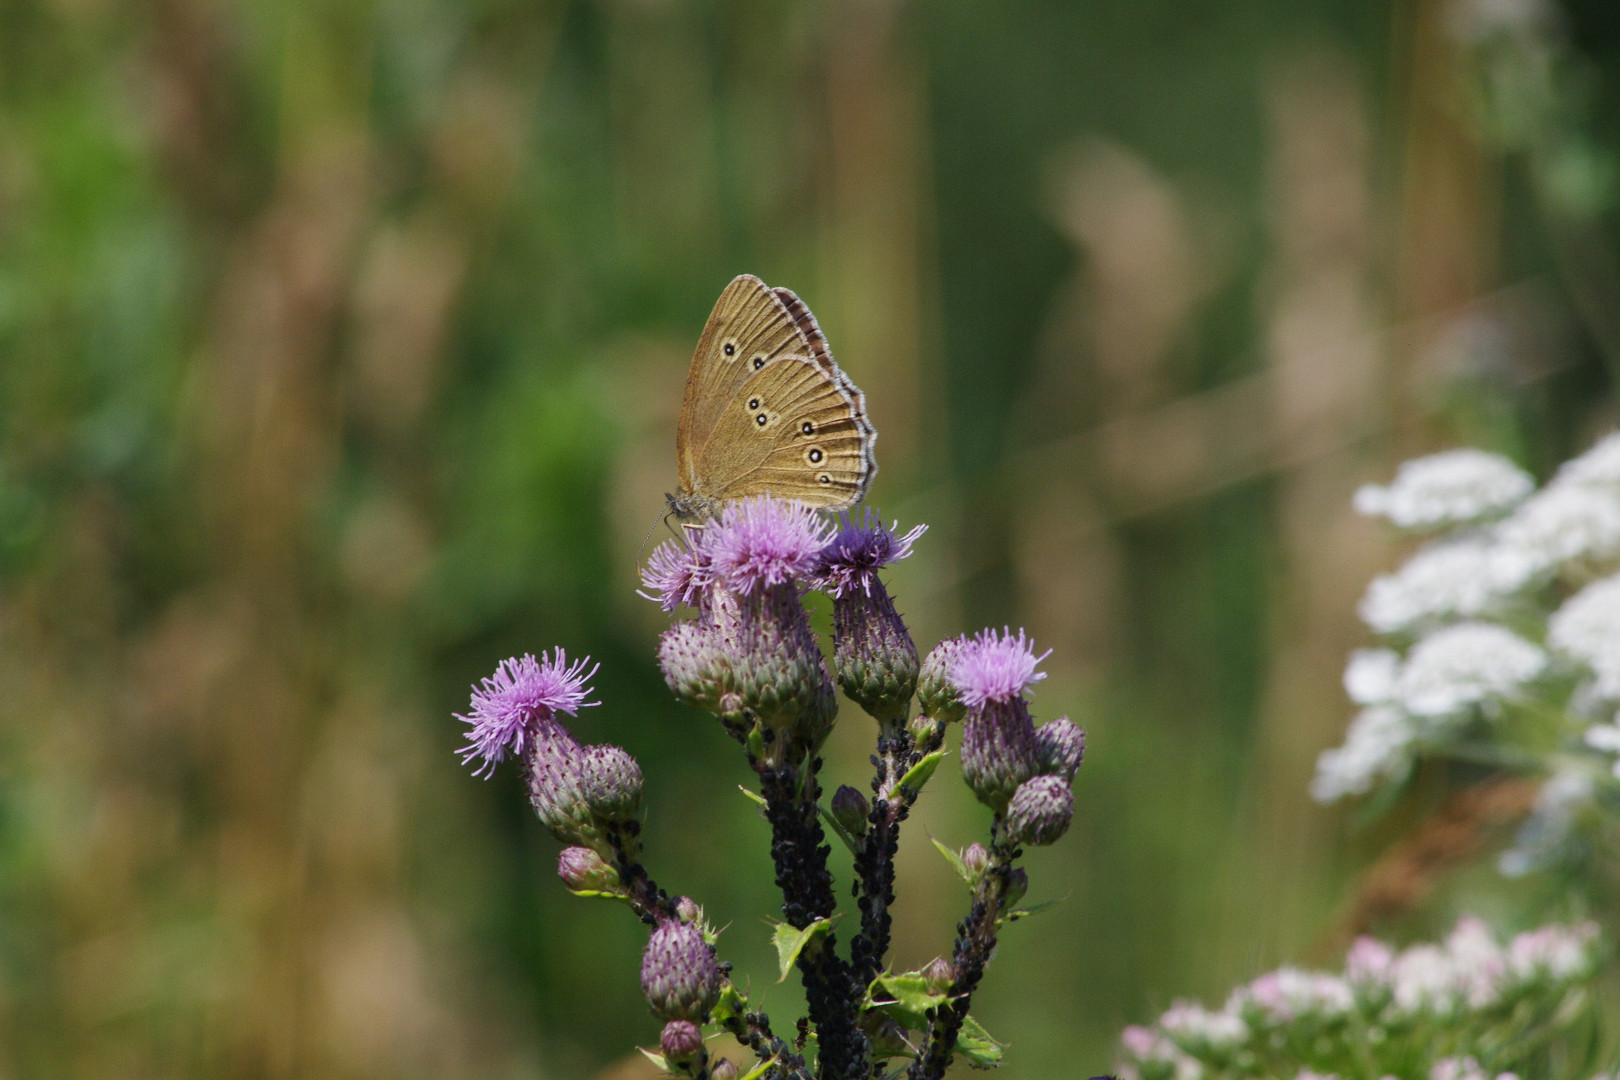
(1119, 918, 1599, 1080)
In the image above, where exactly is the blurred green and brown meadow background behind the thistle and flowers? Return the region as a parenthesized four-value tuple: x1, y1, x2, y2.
(9, 0, 1620, 1080)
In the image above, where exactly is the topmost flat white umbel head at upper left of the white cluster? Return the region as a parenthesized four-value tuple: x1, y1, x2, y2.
(1356, 449, 1536, 531)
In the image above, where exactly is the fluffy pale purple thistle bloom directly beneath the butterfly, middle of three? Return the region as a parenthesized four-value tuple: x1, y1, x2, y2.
(703, 495, 828, 596)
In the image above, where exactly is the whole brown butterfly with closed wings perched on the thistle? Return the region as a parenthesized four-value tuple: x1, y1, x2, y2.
(667, 274, 878, 521)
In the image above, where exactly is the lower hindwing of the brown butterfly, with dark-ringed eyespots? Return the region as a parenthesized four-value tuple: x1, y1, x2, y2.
(692, 356, 878, 510)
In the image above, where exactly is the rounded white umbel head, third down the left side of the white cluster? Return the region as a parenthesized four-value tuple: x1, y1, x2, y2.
(1395, 622, 1547, 719)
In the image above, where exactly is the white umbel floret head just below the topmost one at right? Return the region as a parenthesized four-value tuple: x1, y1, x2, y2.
(1359, 538, 1524, 633)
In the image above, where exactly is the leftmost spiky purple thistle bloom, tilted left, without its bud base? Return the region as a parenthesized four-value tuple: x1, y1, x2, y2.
(455, 648, 599, 779)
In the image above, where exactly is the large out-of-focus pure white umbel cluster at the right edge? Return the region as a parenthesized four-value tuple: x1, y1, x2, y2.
(1311, 432, 1620, 822)
